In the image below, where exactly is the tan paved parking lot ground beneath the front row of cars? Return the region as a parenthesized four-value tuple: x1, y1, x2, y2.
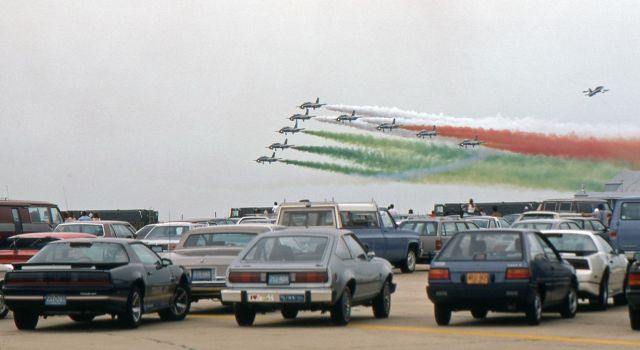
(0, 265, 640, 350)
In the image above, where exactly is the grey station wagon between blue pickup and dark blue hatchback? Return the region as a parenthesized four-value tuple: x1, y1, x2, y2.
(399, 217, 478, 263)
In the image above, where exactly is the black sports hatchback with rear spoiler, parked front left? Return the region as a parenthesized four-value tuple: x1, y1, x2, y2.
(2, 238, 190, 330)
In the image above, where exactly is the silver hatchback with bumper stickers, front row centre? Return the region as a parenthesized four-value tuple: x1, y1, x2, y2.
(222, 228, 395, 326)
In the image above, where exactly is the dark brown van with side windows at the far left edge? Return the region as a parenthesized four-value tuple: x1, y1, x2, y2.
(0, 200, 62, 240)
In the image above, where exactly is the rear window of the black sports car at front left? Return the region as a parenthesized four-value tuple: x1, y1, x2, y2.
(29, 241, 129, 264)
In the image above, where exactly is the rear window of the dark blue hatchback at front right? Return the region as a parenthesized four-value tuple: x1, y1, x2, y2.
(438, 232, 523, 261)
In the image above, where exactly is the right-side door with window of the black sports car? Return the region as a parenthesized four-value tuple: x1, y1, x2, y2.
(131, 243, 176, 309)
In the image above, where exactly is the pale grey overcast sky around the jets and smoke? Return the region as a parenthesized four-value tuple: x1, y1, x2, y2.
(0, 1, 640, 220)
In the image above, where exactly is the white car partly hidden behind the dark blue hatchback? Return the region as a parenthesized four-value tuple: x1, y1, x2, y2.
(542, 230, 628, 310)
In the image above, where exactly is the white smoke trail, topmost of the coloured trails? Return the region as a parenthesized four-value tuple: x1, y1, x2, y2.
(324, 105, 640, 138)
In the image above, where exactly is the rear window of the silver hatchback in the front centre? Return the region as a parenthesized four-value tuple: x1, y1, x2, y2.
(243, 236, 329, 262)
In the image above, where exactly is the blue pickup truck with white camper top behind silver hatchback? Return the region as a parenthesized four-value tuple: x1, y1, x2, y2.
(276, 202, 422, 273)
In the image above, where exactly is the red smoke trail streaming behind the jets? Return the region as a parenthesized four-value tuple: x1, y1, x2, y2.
(403, 125, 640, 167)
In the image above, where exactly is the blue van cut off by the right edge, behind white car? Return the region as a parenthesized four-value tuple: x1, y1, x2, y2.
(609, 197, 640, 260)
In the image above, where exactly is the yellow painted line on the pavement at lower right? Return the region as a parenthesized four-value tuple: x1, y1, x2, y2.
(349, 324, 640, 348)
